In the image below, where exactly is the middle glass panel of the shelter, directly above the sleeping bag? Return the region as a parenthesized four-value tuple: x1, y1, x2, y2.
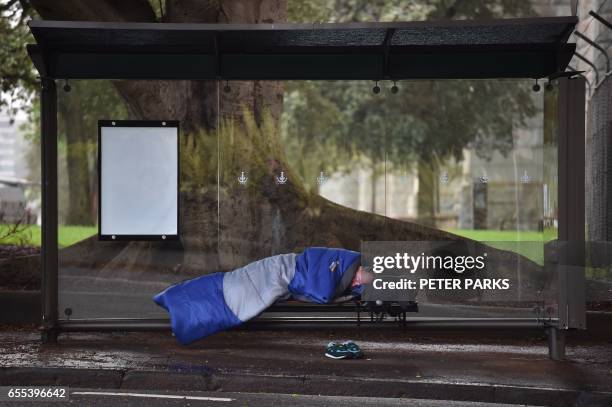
(219, 81, 392, 270)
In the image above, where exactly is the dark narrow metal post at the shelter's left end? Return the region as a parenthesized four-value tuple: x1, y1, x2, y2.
(40, 78, 59, 343)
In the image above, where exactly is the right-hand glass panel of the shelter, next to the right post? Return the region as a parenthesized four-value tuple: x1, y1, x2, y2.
(381, 80, 556, 317)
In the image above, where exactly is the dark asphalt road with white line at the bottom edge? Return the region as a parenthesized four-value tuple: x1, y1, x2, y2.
(7, 389, 536, 407)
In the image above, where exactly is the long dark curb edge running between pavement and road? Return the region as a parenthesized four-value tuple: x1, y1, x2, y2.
(0, 367, 612, 406)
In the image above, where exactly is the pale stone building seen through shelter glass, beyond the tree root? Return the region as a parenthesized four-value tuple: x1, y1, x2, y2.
(319, 103, 548, 231)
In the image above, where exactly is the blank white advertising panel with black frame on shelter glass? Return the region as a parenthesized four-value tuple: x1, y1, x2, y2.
(98, 120, 179, 240)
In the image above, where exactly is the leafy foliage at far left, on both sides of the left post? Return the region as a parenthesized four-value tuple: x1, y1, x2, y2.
(0, 0, 127, 225)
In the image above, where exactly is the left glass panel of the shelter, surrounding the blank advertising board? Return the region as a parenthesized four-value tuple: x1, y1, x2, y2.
(58, 80, 217, 319)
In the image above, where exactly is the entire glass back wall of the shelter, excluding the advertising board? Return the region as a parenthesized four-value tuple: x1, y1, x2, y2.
(58, 81, 556, 319)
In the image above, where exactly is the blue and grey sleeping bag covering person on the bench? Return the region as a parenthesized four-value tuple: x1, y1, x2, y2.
(153, 247, 361, 345)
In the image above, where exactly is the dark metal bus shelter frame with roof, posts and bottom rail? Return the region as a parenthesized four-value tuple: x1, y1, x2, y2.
(28, 17, 585, 359)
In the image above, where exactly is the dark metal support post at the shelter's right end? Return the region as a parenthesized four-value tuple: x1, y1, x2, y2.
(549, 77, 586, 360)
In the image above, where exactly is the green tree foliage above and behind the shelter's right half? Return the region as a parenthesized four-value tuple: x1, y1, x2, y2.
(284, 0, 536, 201)
